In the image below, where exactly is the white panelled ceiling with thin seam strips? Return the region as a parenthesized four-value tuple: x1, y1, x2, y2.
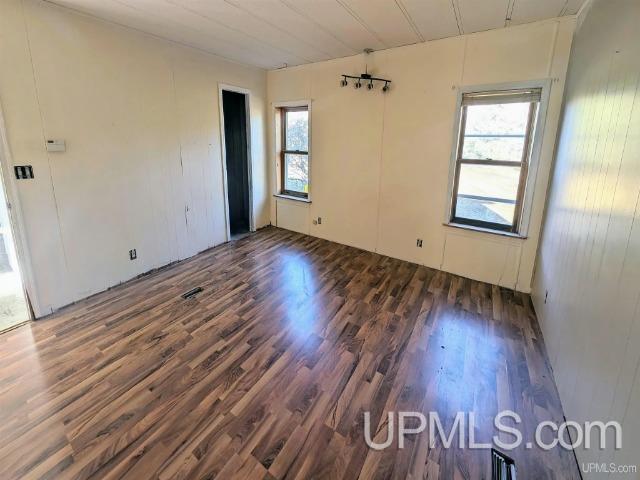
(47, 0, 585, 69)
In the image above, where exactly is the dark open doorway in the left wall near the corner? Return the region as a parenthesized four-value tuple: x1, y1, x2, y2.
(222, 90, 251, 236)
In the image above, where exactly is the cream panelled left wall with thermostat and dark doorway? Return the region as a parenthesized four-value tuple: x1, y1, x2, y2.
(0, 0, 269, 315)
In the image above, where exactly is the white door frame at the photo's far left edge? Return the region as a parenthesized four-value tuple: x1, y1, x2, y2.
(0, 102, 39, 320)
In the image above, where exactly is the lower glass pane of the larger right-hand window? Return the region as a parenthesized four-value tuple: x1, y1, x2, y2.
(456, 163, 520, 225)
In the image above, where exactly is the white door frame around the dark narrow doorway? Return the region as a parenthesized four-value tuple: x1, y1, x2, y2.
(218, 83, 256, 242)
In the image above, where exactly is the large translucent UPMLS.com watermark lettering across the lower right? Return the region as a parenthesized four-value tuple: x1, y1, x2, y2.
(364, 410, 622, 452)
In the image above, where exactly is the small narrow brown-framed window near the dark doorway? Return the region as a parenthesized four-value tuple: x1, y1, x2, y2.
(280, 107, 309, 198)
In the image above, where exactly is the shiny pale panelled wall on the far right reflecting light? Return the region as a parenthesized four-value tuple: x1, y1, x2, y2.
(533, 0, 640, 478)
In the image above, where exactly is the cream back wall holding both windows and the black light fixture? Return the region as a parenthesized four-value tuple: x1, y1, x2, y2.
(267, 18, 575, 292)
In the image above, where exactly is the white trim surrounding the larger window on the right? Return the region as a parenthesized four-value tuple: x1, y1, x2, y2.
(444, 78, 552, 237)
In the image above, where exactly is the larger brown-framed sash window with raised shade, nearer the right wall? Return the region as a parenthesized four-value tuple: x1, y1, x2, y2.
(450, 88, 542, 234)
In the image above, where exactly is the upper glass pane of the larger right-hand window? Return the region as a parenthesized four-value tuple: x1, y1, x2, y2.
(462, 103, 531, 162)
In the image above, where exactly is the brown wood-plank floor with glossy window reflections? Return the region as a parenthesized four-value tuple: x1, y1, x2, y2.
(0, 228, 579, 480)
